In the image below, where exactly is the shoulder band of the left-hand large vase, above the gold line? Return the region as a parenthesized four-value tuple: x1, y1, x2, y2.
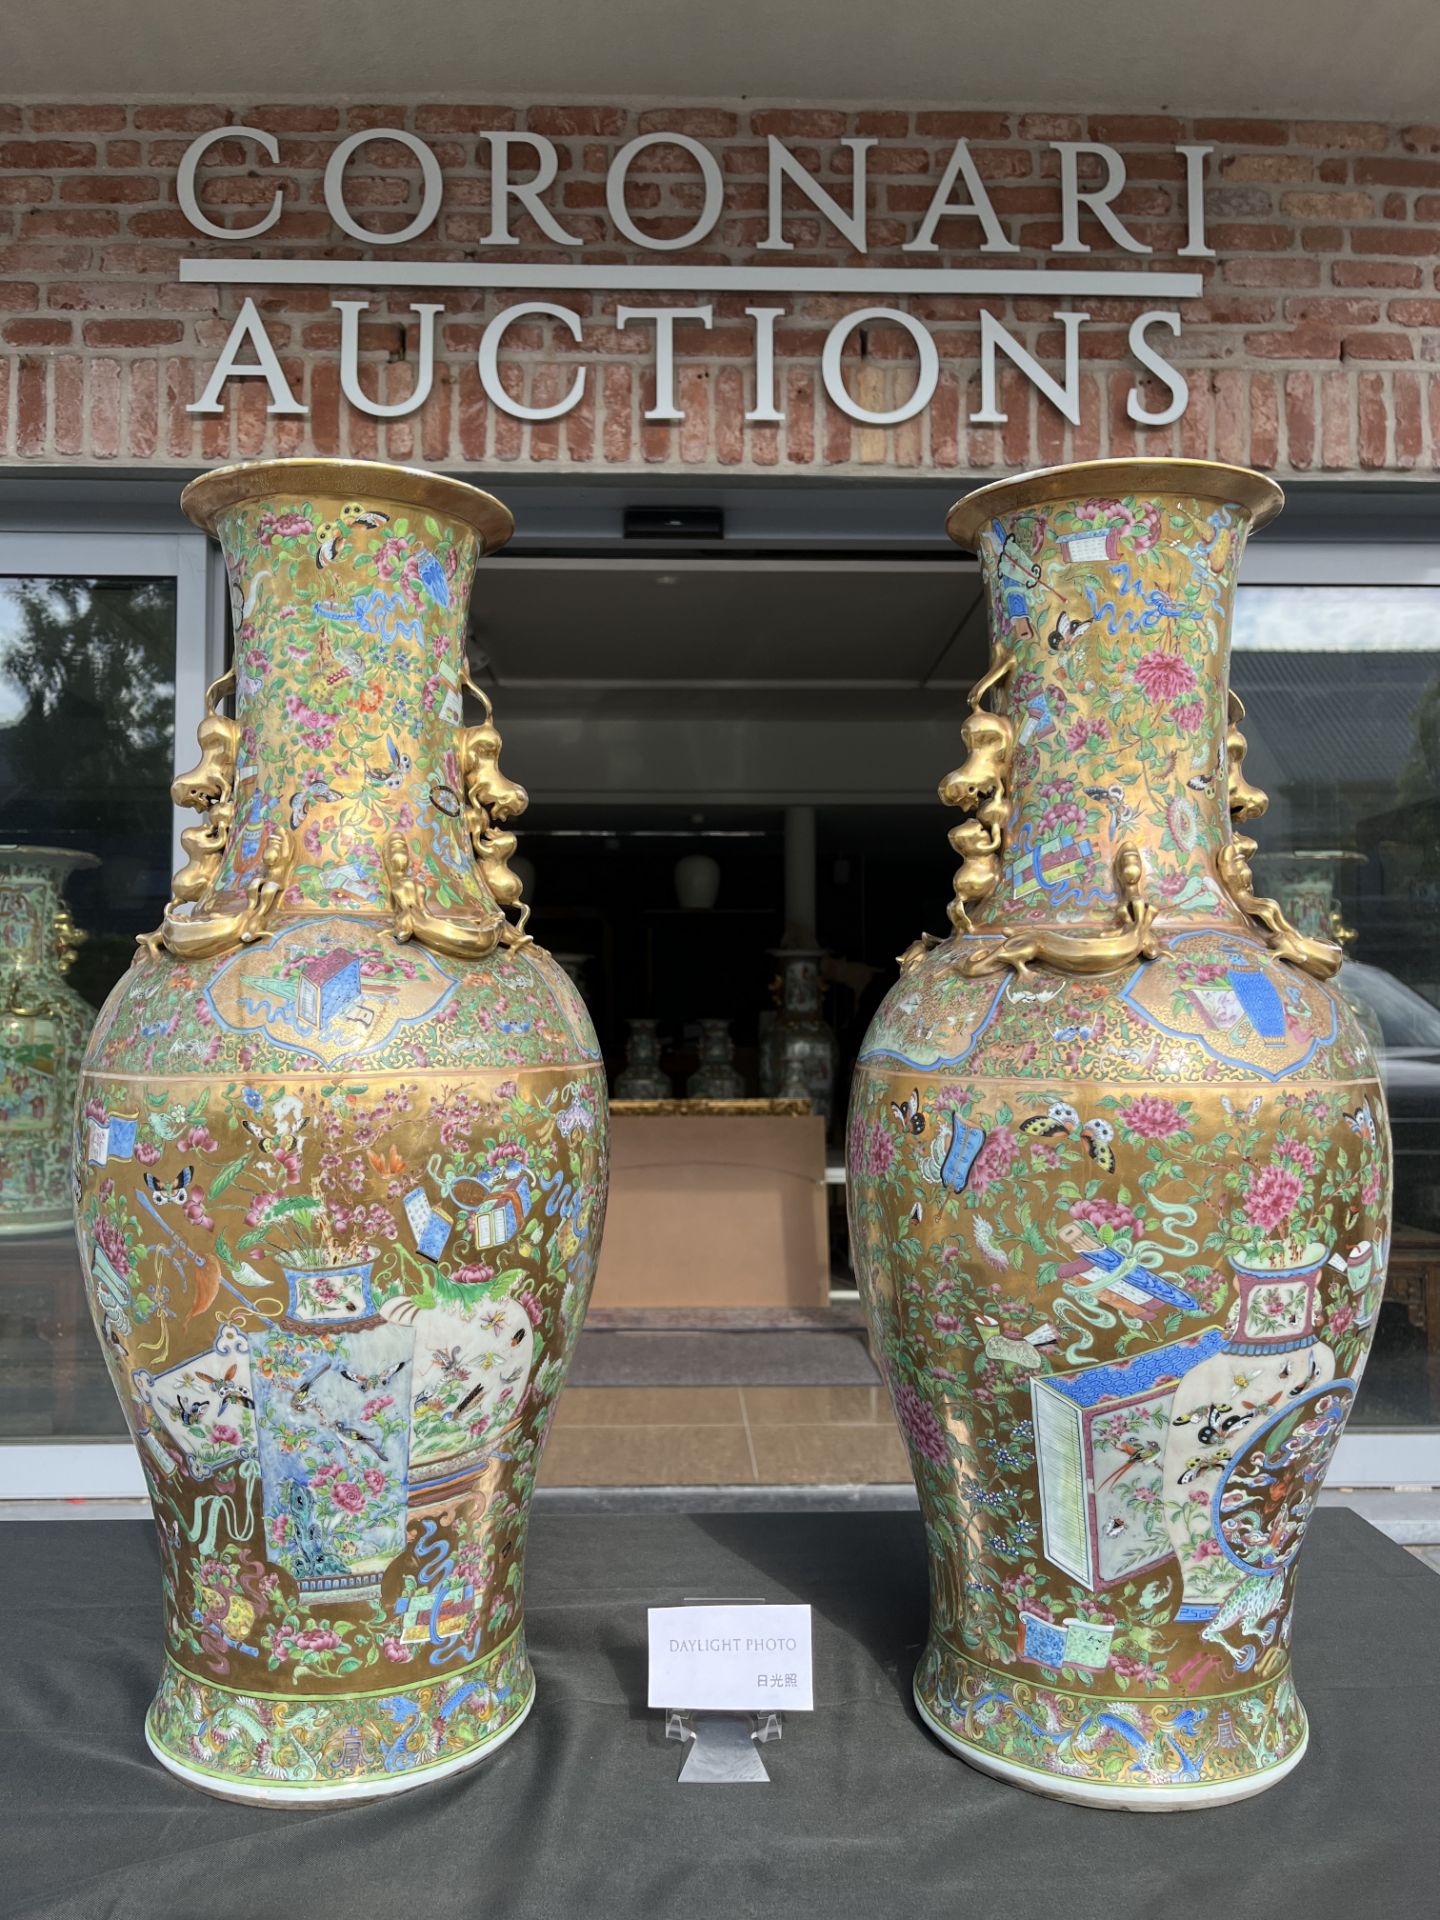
(86, 914, 599, 1077)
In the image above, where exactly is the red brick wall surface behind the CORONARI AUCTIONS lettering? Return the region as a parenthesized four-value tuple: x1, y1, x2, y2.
(0, 102, 1440, 478)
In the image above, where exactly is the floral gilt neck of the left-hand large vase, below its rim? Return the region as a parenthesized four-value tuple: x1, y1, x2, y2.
(203, 493, 490, 912)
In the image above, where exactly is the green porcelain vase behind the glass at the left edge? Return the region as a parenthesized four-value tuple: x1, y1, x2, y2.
(0, 847, 96, 1236)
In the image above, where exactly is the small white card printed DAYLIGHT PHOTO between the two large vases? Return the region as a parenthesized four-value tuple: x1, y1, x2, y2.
(649, 1605, 814, 1713)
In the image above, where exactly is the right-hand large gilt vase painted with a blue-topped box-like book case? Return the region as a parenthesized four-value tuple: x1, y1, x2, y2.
(849, 461, 1390, 1809)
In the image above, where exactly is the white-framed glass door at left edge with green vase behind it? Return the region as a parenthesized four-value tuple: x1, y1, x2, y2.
(0, 534, 211, 1500)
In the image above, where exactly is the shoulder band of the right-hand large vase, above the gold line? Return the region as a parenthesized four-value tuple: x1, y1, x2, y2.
(860, 929, 1379, 1085)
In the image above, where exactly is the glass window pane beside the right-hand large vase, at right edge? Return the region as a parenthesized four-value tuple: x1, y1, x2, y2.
(1233, 586, 1440, 1428)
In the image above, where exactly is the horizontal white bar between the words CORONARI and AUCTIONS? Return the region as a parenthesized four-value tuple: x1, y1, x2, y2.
(180, 259, 1204, 300)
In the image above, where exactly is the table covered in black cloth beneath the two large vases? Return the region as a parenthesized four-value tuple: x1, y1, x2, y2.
(0, 1509, 1440, 1920)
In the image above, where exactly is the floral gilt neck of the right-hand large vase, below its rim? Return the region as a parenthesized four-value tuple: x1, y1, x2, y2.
(973, 495, 1248, 927)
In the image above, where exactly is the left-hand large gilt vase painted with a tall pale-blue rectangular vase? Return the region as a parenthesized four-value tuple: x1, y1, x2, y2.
(75, 461, 607, 1805)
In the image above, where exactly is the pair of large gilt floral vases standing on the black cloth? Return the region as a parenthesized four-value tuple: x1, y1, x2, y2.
(75, 461, 1388, 1809)
